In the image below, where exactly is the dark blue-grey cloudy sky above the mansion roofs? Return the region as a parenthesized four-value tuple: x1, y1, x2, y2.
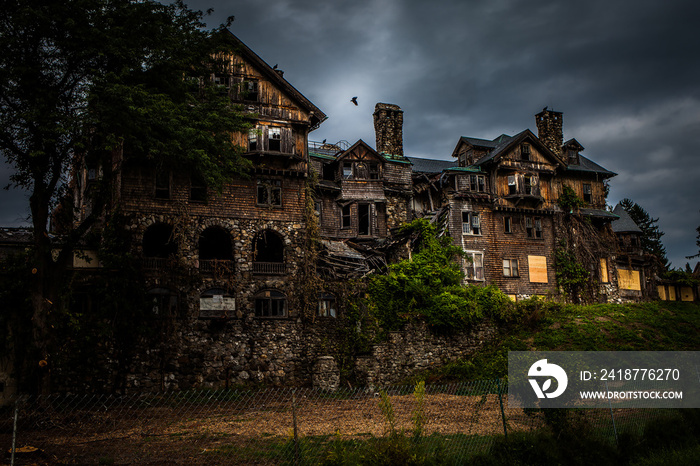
(0, 0, 700, 267)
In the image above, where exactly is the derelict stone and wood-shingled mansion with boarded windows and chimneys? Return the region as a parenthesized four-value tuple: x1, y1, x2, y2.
(1, 31, 668, 388)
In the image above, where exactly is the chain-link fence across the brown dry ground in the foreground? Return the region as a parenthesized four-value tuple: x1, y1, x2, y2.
(0, 380, 688, 465)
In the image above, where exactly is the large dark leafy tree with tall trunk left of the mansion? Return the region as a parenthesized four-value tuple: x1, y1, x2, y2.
(0, 0, 252, 390)
